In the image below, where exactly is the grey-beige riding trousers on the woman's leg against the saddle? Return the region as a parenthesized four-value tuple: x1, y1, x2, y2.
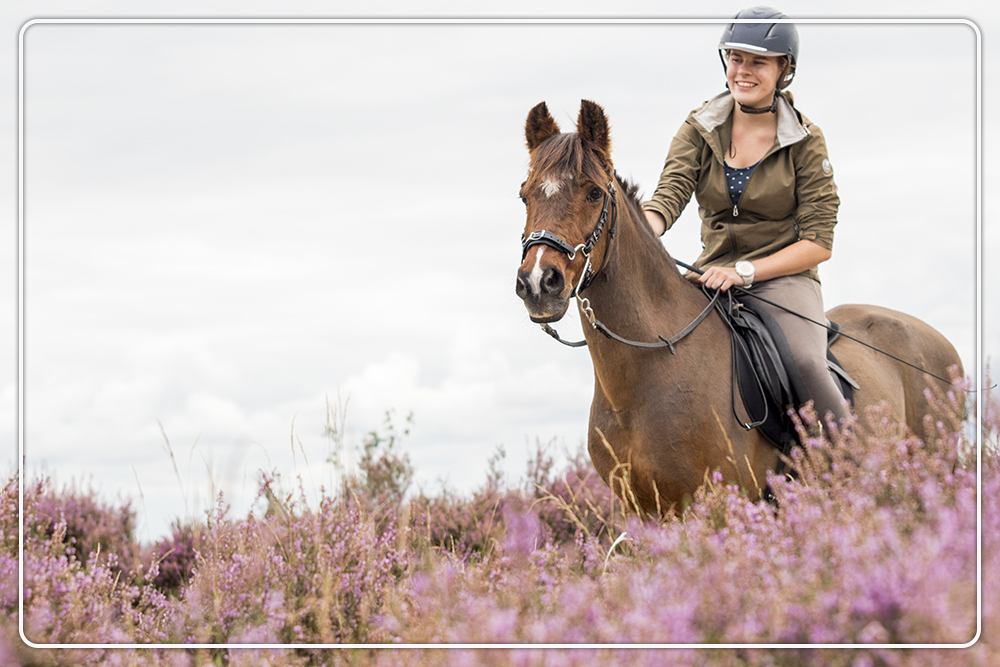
(746, 276, 848, 428)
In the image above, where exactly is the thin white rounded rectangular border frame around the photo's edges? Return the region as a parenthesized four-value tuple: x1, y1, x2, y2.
(16, 18, 984, 650)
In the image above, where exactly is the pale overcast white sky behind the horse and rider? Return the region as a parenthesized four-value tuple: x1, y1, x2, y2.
(0, 1, 1000, 540)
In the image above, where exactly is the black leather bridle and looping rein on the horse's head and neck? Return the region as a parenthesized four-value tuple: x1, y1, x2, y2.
(521, 179, 720, 354)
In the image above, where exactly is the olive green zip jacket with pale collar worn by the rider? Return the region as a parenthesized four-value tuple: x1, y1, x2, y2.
(643, 91, 840, 281)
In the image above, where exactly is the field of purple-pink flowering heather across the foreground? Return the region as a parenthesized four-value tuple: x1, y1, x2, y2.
(0, 380, 1000, 667)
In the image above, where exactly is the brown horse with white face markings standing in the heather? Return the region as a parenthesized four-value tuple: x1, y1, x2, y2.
(517, 100, 961, 513)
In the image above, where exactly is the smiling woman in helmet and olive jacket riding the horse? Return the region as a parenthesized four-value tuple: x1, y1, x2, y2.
(643, 7, 848, 428)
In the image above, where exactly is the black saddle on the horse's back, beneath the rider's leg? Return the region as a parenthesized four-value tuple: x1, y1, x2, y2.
(719, 296, 859, 474)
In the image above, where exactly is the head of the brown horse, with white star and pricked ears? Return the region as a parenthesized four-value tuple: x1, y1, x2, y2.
(516, 100, 616, 322)
